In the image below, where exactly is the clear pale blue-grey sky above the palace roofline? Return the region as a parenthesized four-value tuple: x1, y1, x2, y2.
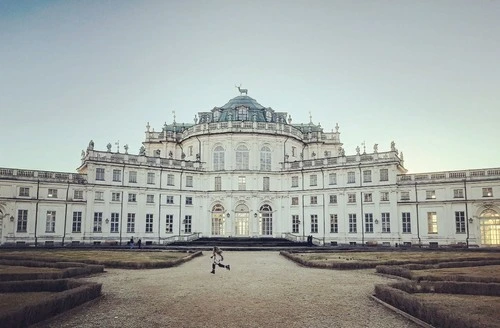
(0, 0, 500, 173)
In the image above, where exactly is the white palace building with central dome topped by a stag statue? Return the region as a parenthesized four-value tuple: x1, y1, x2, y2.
(0, 90, 500, 246)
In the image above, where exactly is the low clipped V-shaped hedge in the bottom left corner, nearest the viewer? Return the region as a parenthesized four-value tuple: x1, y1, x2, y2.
(0, 279, 102, 328)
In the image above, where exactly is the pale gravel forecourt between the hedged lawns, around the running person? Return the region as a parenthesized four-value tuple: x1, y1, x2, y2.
(34, 252, 418, 328)
